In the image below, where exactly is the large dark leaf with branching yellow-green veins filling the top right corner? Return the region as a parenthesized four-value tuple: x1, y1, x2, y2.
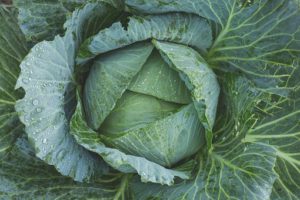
(126, 0, 300, 96)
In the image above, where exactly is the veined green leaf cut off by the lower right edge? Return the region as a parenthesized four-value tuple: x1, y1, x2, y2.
(245, 100, 300, 200)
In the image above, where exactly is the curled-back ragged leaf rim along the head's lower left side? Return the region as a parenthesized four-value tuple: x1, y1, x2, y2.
(71, 98, 188, 185)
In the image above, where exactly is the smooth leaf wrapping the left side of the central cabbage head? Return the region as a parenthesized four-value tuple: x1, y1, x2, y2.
(84, 43, 153, 130)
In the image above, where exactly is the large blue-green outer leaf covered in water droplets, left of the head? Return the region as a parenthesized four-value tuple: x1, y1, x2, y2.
(16, 3, 122, 181)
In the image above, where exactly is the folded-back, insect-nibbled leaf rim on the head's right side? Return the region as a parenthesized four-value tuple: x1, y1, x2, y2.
(153, 40, 220, 148)
